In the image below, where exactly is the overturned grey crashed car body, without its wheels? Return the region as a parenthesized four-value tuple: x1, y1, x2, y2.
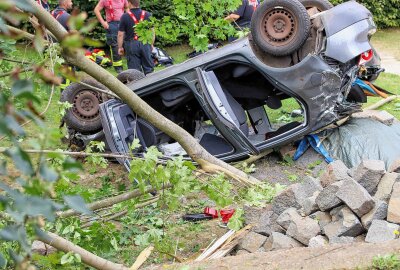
(62, 1, 380, 167)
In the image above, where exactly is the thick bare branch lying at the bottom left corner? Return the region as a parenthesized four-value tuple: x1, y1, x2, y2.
(39, 232, 130, 270)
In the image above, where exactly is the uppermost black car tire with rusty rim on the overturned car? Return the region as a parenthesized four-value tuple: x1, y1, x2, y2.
(251, 0, 311, 56)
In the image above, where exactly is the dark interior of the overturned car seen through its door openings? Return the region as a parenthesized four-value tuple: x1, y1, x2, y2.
(104, 63, 304, 156)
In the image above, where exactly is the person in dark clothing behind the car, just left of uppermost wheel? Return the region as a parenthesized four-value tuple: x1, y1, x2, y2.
(225, 0, 260, 42)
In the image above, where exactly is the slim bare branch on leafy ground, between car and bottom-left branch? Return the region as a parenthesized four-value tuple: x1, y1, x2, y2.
(56, 184, 172, 218)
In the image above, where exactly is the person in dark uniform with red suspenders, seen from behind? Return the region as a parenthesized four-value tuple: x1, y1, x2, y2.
(118, 0, 154, 74)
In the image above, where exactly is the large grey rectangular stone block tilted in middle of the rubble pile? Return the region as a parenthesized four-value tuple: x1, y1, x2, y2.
(336, 179, 375, 217)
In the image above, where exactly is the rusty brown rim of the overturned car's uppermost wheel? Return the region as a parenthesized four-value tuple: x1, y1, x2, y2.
(261, 7, 297, 46)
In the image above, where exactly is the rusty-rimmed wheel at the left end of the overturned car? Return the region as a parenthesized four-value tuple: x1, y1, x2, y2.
(60, 78, 107, 134)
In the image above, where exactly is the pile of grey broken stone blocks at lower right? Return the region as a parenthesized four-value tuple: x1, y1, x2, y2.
(237, 160, 400, 254)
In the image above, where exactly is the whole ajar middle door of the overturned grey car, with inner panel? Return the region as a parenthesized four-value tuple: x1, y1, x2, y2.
(196, 68, 260, 155)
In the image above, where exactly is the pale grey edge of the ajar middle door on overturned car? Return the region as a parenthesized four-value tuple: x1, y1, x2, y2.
(196, 68, 260, 155)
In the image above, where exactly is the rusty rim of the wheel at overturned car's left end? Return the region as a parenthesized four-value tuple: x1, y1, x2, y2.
(73, 90, 101, 120)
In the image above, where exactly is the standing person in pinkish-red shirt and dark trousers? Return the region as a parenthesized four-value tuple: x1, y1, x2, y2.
(94, 0, 128, 73)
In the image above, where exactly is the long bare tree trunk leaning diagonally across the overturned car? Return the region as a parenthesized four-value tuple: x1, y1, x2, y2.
(28, 0, 260, 185)
